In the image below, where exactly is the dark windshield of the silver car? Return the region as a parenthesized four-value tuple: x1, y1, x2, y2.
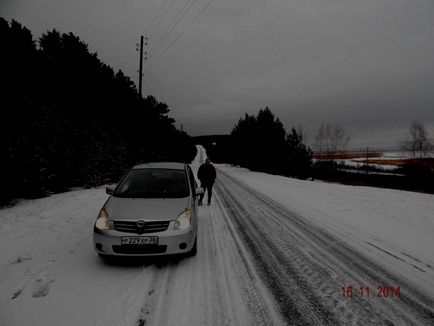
(113, 169, 189, 198)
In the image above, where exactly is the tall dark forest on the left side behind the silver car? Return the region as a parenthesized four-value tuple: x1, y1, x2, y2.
(0, 17, 196, 201)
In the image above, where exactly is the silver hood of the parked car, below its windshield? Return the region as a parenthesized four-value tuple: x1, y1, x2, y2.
(105, 196, 189, 221)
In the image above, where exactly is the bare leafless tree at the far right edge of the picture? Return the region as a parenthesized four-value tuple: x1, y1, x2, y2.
(401, 121, 432, 159)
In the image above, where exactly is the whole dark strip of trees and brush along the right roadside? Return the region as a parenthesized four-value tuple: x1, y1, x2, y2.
(194, 108, 434, 193)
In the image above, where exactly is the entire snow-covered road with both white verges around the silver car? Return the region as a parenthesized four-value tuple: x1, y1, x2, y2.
(0, 149, 434, 326)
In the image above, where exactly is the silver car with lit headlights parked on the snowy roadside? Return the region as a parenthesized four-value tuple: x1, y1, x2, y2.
(93, 163, 203, 257)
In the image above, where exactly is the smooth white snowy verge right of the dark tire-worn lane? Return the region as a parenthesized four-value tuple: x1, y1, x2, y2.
(220, 165, 434, 294)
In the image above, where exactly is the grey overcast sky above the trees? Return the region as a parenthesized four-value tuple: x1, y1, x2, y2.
(0, 0, 434, 148)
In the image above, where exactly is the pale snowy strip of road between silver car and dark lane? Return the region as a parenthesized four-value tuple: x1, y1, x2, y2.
(134, 185, 283, 326)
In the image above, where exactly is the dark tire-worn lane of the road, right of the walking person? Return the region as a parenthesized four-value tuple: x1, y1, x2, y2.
(216, 171, 434, 325)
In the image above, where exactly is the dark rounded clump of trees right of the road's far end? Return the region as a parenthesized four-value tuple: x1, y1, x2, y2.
(194, 108, 312, 178)
